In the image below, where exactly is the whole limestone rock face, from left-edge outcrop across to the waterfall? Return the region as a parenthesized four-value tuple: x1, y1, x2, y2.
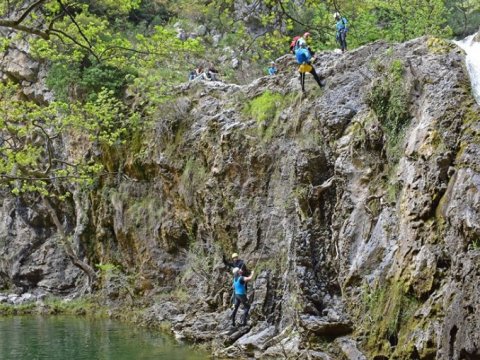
(0, 34, 480, 360)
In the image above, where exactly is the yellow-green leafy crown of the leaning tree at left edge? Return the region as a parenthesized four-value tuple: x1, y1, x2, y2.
(0, 83, 139, 198)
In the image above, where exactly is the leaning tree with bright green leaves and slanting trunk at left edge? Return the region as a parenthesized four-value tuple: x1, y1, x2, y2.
(0, 83, 138, 286)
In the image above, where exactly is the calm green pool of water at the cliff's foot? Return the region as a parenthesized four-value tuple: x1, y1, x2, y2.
(0, 316, 208, 360)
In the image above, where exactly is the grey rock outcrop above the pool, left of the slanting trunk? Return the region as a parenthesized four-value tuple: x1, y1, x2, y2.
(0, 194, 81, 295)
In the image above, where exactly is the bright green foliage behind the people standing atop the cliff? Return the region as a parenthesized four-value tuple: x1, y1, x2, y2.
(281, 0, 451, 49)
